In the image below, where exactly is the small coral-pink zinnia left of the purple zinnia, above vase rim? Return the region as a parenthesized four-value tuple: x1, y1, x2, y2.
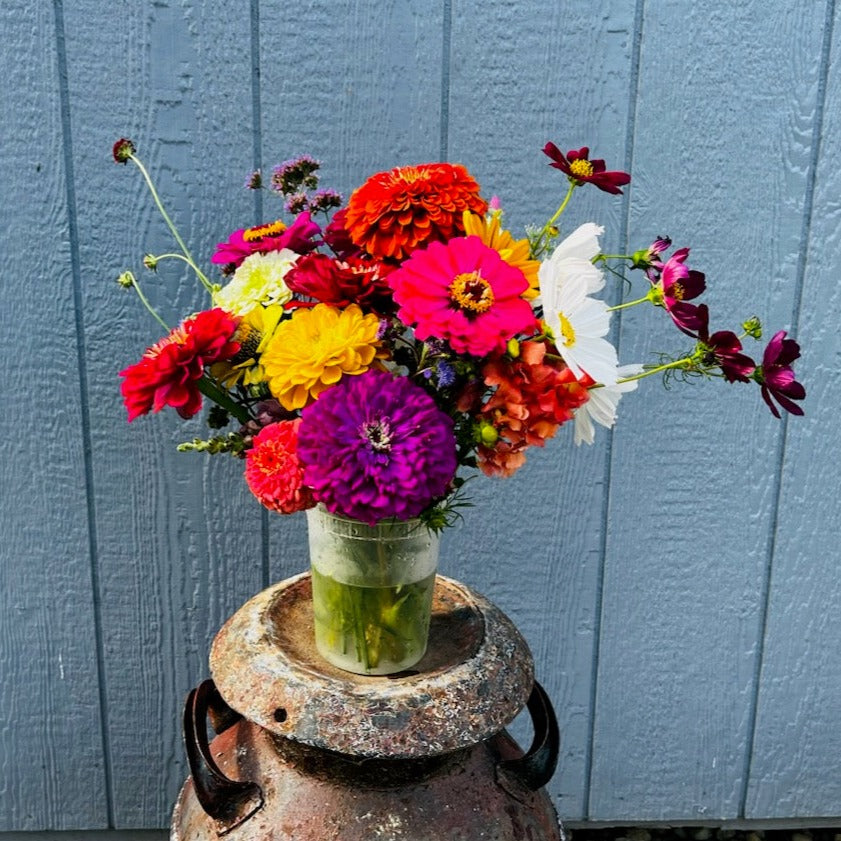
(245, 418, 315, 514)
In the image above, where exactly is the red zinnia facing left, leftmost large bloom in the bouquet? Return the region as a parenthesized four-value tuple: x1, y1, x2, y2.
(120, 308, 240, 421)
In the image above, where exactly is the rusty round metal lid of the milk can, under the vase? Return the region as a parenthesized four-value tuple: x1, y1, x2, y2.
(210, 573, 534, 759)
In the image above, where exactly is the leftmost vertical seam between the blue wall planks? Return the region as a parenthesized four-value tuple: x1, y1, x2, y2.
(53, 0, 116, 829)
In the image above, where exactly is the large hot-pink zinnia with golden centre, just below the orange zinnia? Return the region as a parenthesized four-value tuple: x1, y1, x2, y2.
(388, 236, 536, 356)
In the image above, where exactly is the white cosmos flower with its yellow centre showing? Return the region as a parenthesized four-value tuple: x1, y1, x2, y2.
(538, 258, 619, 385)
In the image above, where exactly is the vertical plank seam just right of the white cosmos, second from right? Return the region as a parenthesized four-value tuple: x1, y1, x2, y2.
(582, 0, 645, 820)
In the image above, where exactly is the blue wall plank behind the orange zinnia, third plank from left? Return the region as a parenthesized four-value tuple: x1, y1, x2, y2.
(260, 0, 442, 581)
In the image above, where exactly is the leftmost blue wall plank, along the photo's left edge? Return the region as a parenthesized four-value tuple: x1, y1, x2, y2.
(0, 0, 108, 831)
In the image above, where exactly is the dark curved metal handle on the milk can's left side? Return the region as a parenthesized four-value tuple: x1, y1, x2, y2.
(184, 679, 263, 835)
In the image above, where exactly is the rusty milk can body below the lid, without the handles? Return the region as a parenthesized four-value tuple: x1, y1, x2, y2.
(171, 721, 562, 841)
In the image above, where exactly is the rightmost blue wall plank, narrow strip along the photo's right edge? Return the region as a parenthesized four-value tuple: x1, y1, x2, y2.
(745, 4, 841, 819)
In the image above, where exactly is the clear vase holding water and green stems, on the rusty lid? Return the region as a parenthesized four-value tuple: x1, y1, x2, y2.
(307, 505, 440, 675)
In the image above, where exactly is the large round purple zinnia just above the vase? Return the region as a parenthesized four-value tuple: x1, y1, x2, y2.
(298, 369, 457, 525)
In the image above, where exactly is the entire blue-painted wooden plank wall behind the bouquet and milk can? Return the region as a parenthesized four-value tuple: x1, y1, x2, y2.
(0, 0, 841, 830)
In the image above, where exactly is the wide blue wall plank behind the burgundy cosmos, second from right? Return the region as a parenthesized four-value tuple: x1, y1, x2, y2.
(590, 2, 823, 821)
